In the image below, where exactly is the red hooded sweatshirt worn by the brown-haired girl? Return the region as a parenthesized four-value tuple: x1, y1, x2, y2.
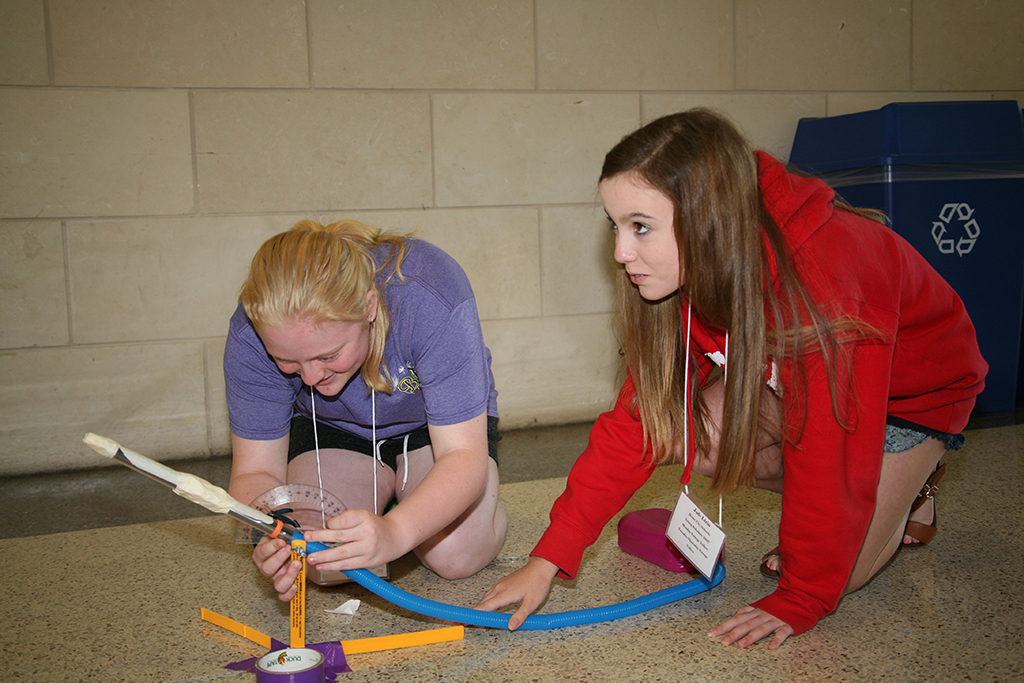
(531, 153, 988, 634)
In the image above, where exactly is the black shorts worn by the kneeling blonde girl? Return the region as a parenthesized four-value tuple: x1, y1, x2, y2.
(288, 415, 502, 471)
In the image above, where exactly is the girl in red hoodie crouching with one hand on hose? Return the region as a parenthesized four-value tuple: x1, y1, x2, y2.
(478, 110, 987, 648)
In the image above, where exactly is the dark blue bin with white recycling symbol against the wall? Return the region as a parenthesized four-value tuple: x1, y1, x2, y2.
(790, 100, 1024, 416)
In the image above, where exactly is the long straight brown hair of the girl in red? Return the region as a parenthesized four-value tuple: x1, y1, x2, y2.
(600, 109, 876, 493)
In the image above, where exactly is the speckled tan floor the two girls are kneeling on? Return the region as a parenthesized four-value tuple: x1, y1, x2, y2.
(0, 417, 1024, 683)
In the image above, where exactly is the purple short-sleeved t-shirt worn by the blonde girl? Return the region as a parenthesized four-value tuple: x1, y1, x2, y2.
(224, 239, 498, 440)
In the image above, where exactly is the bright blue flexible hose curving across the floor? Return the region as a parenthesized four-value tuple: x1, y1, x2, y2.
(296, 533, 725, 631)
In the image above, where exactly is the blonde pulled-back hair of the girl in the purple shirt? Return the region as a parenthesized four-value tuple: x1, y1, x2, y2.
(239, 219, 408, 393)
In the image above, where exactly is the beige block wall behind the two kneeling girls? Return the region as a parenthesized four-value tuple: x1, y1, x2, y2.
(0, 0, 1024, 474)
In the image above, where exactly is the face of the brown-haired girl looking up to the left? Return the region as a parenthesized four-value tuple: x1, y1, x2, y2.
(599, 173, 683, 301)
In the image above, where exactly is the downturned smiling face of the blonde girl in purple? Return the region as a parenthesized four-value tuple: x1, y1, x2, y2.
(259, 292, 377, 396)
